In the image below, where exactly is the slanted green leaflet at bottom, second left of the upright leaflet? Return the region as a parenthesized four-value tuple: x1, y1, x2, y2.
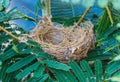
(69, 61, 87, 82)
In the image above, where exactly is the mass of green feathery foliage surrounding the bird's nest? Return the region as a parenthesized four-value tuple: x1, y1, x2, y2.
(0, 0, 120, 82)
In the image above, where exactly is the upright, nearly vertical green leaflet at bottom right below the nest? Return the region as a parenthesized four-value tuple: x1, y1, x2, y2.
(95, 60, 103, 82)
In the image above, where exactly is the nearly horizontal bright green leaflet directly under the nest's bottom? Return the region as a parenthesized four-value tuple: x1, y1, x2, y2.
(44, 60, 70, 71)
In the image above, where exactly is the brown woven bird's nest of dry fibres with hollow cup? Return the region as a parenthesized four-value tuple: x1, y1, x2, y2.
(30, 17, 94, 63)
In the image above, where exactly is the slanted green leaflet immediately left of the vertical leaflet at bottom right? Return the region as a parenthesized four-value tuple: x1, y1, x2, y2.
(80, 60, 95, 82)
